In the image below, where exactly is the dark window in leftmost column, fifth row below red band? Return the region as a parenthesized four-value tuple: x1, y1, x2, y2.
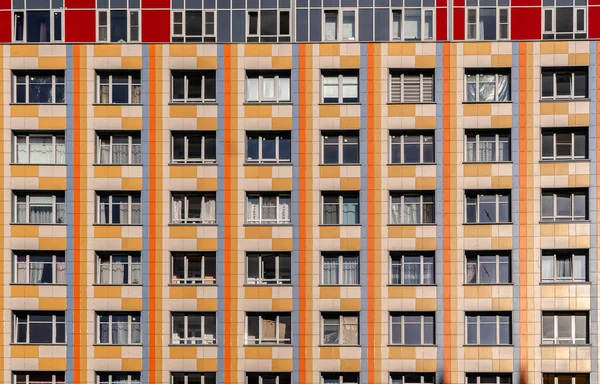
(13, 311, 66, 344)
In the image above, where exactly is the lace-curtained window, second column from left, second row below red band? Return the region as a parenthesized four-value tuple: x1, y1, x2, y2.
(96, 132, 142, 165)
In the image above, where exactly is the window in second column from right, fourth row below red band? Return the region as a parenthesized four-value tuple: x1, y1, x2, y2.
(465, 251, 512, 284)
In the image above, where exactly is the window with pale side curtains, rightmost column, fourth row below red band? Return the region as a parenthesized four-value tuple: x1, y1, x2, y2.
(542, 249, 588, 283)
